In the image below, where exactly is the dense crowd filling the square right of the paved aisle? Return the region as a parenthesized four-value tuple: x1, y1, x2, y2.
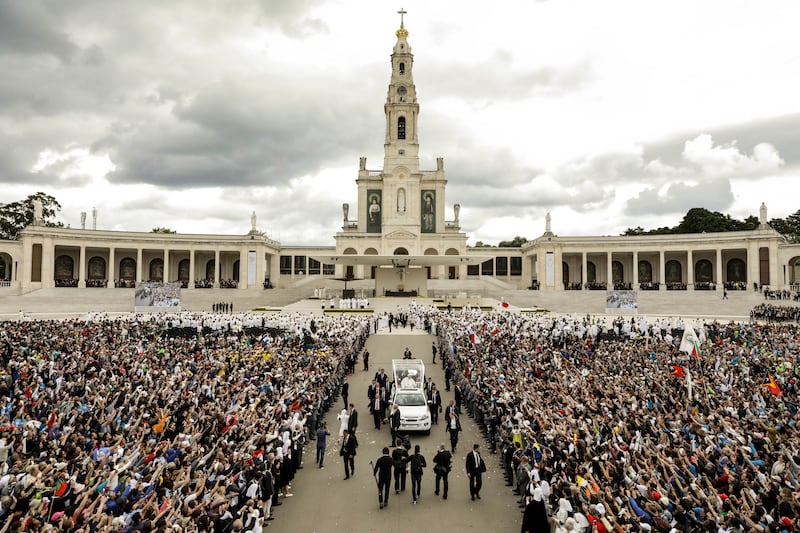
(431, 310, 800, 532)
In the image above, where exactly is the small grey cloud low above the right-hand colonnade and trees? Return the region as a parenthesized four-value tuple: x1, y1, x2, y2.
(623, 179, 734, 216)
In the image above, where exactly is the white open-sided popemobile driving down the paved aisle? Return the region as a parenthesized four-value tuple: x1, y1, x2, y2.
(392, 359, 431, 433)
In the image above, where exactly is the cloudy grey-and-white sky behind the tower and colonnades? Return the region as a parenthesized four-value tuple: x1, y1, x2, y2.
(0, 0, 800, 244)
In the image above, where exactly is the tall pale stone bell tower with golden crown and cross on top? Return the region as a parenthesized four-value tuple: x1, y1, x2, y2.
(383, 9, 419, 173)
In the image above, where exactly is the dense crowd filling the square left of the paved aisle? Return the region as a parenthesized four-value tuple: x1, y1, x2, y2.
(0, 313, 368, 532)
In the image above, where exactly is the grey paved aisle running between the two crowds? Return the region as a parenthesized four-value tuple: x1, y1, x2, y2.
(266, 328, 522, 533)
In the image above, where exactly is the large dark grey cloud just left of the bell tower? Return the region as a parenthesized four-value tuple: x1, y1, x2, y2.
(102, 72, 383, 188)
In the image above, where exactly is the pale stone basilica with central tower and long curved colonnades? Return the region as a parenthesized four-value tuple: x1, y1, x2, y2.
(0, 18, 800, 296)
